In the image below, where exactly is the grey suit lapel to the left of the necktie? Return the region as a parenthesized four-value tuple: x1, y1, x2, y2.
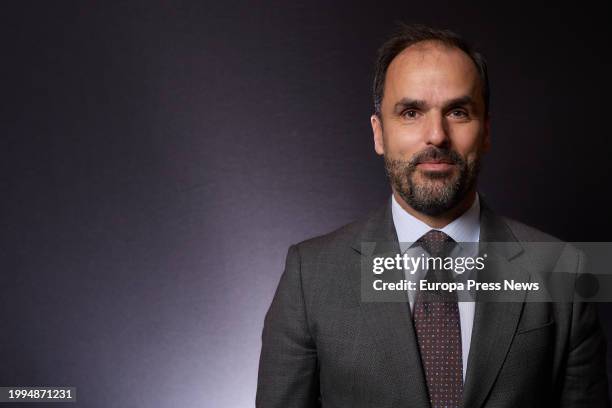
(353, 203, 429, 407)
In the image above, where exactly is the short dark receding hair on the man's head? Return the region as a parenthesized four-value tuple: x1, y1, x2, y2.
(373, 24, 490, 117)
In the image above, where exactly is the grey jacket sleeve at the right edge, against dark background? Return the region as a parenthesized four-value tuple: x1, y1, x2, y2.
(560, 252, 610, 408)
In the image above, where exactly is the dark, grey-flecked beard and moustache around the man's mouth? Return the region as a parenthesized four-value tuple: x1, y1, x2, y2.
(385, 147, 480, 216)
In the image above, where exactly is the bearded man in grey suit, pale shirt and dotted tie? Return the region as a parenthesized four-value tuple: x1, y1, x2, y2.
(256, 26, 610, 408)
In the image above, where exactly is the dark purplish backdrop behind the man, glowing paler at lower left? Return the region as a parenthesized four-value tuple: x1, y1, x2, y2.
(0, 0, 612, 408)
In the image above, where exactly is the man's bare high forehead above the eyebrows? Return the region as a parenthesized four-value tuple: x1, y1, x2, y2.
(383, 41, 482, 104)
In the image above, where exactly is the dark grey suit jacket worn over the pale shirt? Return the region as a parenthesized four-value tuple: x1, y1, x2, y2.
(256, 203, 610, 408)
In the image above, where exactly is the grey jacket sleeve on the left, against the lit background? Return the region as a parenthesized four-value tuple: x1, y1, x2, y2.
(256, 246, 320, 408)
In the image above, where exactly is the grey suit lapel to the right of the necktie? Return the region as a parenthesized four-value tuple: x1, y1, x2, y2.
(463, 200, 529, 408)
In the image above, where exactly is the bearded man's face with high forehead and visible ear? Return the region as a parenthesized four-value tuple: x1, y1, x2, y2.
(371, 42, 489, 216)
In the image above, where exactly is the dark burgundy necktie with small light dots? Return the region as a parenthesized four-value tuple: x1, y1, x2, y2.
(413, 230, 463, 408)
